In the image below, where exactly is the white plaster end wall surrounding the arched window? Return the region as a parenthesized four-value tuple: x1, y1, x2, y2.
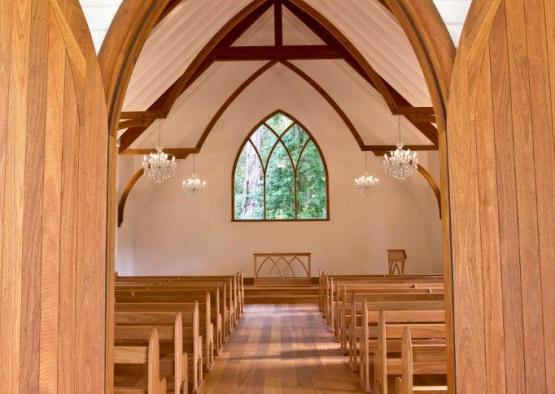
(117, 64, 442, 276)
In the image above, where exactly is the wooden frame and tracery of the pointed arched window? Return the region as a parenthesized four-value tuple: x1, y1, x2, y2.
(231, 109, 330, 223)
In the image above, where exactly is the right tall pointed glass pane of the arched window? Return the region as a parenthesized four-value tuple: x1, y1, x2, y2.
(297, 141, 327, 219)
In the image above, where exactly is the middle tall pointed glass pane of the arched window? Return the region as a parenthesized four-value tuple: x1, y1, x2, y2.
(266, 142, 295, 220)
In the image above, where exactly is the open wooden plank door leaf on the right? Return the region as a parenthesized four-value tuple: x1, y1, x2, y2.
(447, 0, 555, 394)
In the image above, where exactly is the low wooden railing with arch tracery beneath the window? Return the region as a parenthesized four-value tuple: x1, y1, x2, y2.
(253, 253, 312, 284)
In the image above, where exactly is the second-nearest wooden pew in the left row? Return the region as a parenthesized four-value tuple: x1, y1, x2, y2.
(114, 312, 188, 394)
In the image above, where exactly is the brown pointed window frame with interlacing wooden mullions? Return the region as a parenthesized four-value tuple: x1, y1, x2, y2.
(231, 109, 330, 223)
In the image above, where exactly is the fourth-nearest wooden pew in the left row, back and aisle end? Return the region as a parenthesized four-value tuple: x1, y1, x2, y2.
(116, 291, 217, 371)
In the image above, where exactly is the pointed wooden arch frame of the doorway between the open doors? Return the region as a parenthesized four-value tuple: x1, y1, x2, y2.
(99, 0, 456, 392)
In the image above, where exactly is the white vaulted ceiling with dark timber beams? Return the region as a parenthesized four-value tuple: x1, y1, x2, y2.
(105, 0, 460, 157)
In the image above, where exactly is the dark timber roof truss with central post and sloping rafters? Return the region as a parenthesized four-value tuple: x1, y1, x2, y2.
(119, 0, 438, 152)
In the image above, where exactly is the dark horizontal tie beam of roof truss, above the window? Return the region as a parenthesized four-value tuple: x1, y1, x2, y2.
(216, 45, 343, 61)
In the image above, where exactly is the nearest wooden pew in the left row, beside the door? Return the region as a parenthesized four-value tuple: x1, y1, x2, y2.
(113, 329, 166, 394)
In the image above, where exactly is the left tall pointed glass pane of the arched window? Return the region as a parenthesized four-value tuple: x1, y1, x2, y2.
(234, 142, 264, 220)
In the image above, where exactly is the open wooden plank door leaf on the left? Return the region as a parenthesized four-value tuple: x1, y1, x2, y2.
(0, 0, 108, 394)
